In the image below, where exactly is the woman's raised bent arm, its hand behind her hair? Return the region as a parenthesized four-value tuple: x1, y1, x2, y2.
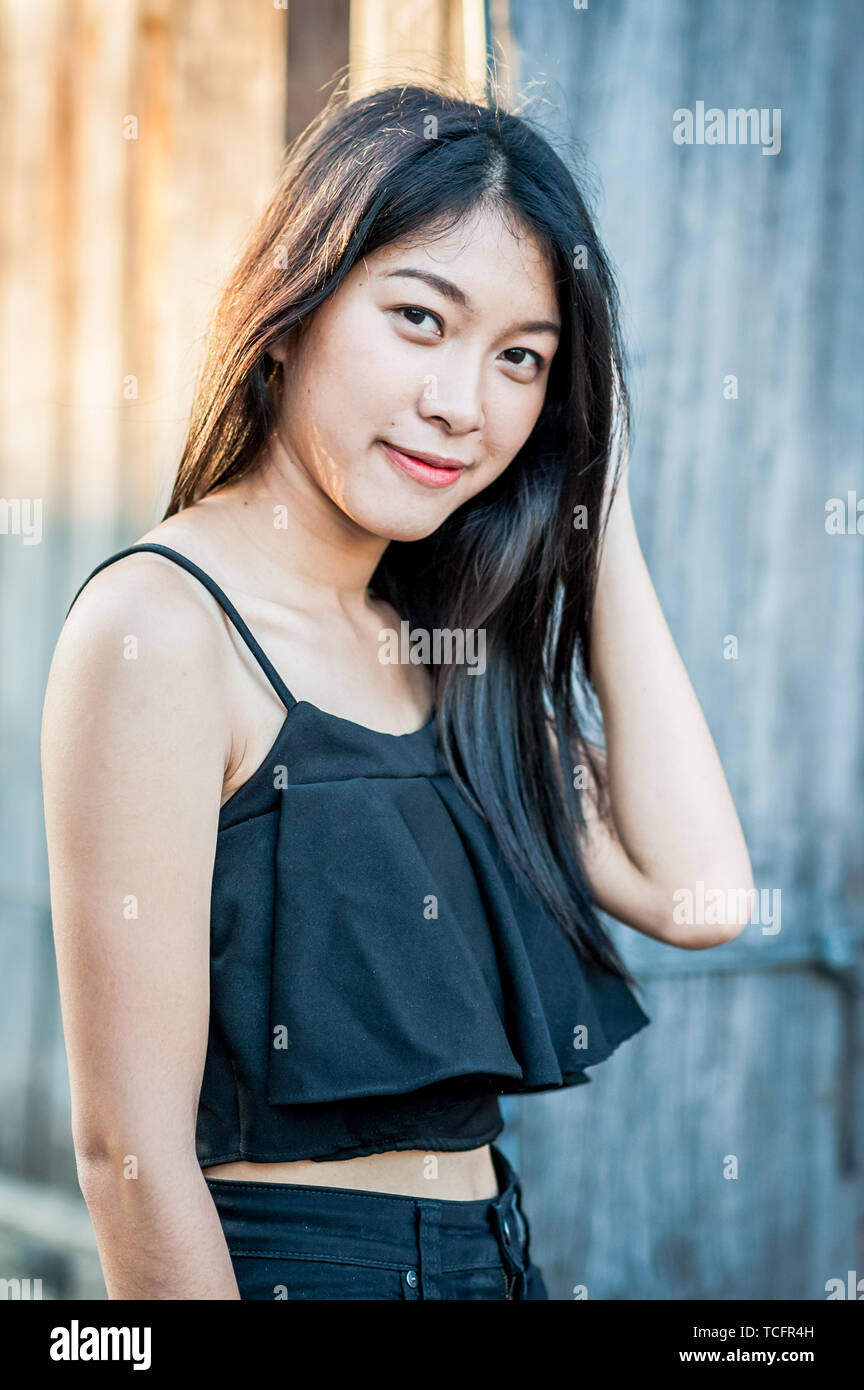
(566, 471, 753, 949)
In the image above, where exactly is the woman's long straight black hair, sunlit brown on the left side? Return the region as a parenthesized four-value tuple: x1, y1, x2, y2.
(165, 83, 635, 984)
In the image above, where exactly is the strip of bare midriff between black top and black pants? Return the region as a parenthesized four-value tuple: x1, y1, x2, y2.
(201, 1144, 499, 1202)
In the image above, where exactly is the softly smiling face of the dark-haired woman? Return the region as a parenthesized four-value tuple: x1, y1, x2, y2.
(271, 202, 561, 541)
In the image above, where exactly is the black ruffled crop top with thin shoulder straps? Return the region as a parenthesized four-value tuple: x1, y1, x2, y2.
(69, 543, 650, 1168)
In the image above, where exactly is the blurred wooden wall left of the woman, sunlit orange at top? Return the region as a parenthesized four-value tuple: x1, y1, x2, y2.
(0, 0, 286, 1183)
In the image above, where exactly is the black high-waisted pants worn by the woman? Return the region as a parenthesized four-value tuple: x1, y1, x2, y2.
(206, 1144, 549, 1300)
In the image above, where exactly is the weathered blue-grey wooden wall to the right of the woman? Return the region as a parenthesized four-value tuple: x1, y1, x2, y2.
(495, 0, 864, 1300)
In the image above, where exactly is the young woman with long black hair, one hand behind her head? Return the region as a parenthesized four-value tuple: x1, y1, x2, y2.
(43, 86, 751, 1300)
